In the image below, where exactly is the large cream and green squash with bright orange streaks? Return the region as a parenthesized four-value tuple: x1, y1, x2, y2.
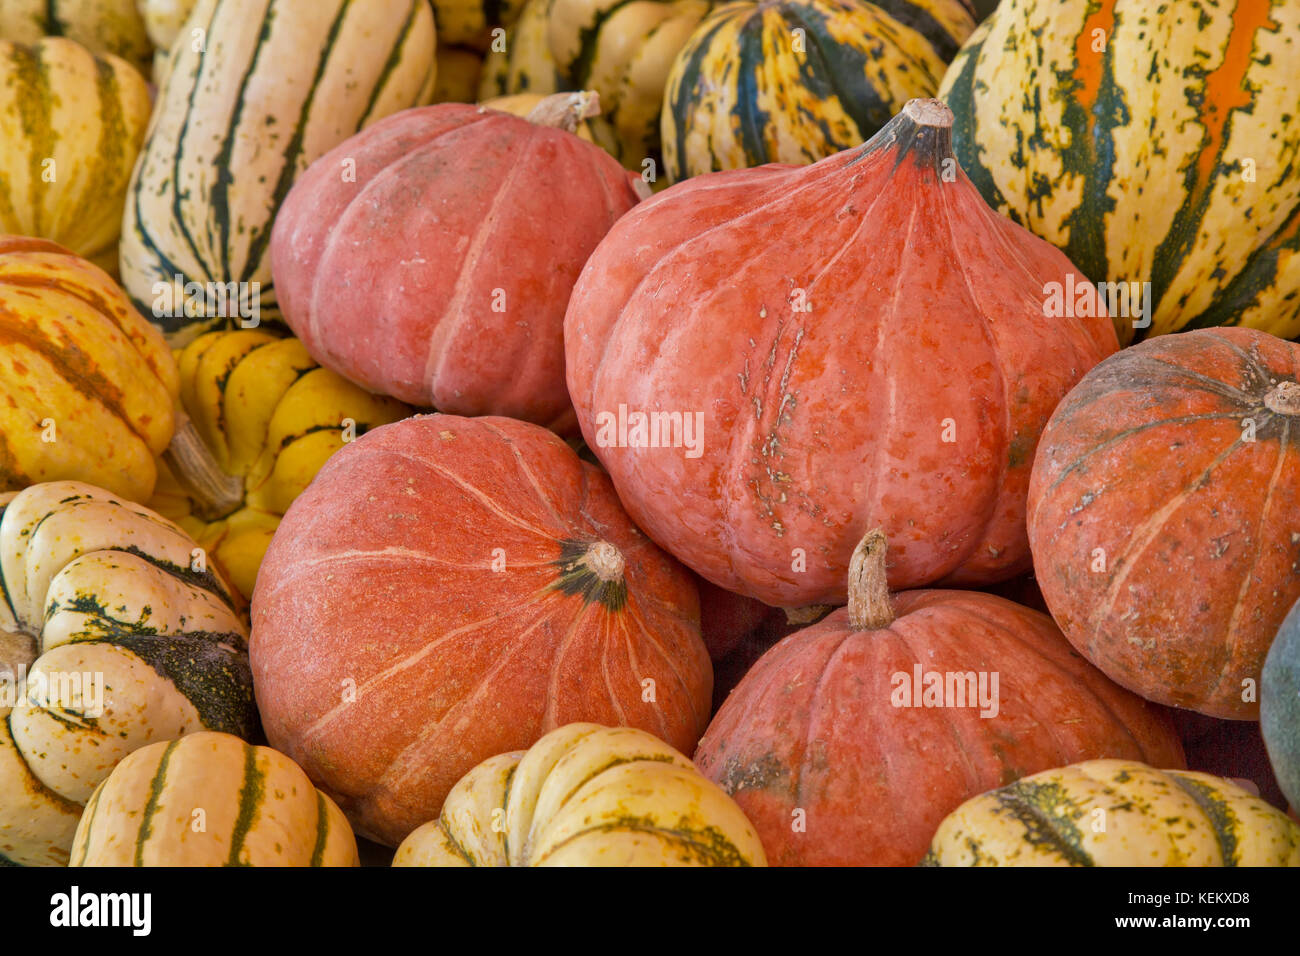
(940, 0, 1300, 338)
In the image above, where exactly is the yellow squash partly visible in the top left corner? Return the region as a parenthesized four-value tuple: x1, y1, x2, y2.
(0, 0, 153, 72)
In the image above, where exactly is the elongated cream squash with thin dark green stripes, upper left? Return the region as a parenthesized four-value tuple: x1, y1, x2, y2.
(121, 0, 436, 347)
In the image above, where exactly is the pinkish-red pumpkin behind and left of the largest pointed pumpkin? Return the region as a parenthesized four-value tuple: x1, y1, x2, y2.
(270, 94, 637, 431)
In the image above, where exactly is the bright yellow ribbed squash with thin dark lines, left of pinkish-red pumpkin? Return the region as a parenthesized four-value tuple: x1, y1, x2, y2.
(150, 329, 412, 598)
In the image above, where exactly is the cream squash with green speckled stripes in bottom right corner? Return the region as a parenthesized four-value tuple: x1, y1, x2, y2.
(922, 760, 1300, 866)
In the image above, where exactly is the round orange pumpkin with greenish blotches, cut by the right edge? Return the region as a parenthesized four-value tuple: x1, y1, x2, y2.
(1028, 329, 1300, 721)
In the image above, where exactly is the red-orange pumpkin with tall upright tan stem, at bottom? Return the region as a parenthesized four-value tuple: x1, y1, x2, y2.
(696, 532, 1183, 866)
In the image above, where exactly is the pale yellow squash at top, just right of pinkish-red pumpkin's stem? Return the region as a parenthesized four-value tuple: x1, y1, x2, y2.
(546, 0, 711, 171)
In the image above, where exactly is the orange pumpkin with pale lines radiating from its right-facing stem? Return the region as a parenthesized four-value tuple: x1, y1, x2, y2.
(251, 415, 712, 845)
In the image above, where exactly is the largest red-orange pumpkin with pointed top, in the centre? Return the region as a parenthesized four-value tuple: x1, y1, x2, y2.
(564, 100, 1118, 606)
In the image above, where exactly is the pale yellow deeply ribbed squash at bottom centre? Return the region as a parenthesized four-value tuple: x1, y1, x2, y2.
(393, 723, 767, 866)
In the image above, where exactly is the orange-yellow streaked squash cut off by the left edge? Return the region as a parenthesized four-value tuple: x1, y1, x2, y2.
(0, 235, 179, 501)
